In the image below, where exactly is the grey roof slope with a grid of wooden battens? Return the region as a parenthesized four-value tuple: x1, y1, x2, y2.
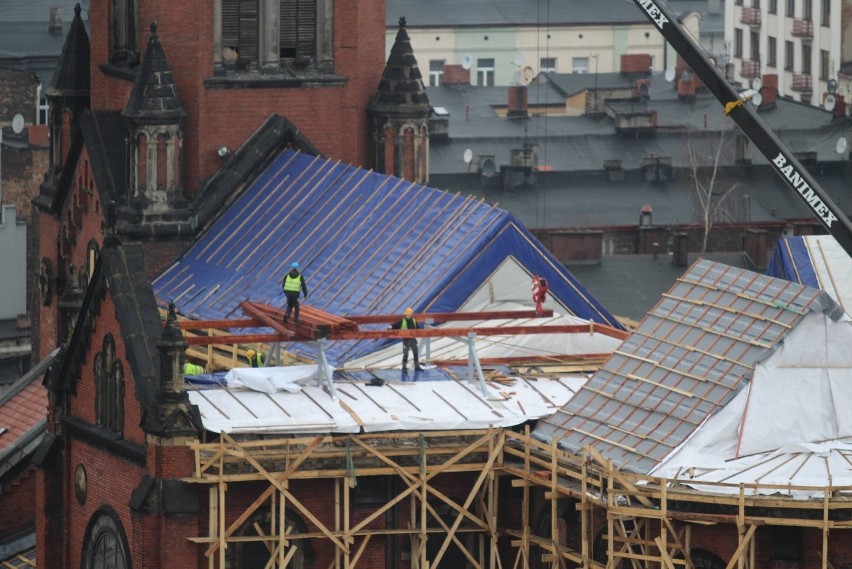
(534, 260, 842, 473)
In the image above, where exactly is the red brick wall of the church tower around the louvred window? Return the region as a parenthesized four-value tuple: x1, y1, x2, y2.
(89, 0, 385, 195)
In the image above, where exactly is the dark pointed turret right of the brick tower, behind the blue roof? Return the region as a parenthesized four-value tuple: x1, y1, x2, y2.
(367, 17, 432, 184)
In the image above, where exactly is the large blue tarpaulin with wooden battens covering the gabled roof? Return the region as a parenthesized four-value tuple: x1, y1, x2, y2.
(154, 150, 621, 364)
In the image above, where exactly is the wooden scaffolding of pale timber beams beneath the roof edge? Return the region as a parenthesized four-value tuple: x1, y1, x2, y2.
(187, 429, 852, 569)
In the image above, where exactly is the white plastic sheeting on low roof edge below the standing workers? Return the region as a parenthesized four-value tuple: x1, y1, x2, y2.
(188, 366, 586, 434)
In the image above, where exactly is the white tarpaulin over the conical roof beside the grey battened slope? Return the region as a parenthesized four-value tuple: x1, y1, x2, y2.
(652, 312, 852, 498)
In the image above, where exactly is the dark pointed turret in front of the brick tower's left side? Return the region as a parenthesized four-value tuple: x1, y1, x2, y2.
(121, 22, 186, 218)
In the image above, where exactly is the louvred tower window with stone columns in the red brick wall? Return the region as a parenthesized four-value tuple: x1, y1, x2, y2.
(214, 0, 333, 73)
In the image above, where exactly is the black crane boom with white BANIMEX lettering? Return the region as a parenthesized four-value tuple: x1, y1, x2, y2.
(633, 0, 852, 256)
